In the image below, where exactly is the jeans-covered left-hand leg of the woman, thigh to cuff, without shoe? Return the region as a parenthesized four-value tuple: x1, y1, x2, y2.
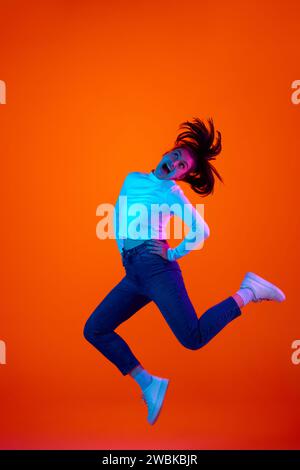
(84, 276, 150, 375)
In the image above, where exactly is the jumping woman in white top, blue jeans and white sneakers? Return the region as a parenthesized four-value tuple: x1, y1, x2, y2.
(84, 118, 285, 424)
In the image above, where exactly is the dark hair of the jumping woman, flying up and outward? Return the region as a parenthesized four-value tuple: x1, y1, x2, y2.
(174, 118, 223, 197)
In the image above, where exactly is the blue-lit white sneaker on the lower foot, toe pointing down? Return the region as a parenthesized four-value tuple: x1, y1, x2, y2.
(142, 376, 169, 424)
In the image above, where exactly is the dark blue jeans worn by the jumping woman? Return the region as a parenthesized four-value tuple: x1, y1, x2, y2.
(84, 240, 241, 375)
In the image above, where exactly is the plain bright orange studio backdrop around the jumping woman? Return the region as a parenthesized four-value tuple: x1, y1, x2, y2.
(0, 0, 300, 449)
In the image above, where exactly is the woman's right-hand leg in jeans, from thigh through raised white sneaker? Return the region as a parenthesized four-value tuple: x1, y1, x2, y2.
(149, 269, 285, 349)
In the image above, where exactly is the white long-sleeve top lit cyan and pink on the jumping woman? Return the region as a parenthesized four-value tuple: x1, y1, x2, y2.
(114, 171, 209, 261)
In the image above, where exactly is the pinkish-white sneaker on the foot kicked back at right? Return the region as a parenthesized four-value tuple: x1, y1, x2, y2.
(240, 272, 285, 302)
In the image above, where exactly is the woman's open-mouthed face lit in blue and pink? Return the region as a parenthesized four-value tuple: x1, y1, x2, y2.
(154, 147, 194, 180)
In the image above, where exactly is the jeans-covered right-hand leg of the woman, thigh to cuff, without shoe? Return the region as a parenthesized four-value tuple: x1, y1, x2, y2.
(150, 269, 241, 349)
